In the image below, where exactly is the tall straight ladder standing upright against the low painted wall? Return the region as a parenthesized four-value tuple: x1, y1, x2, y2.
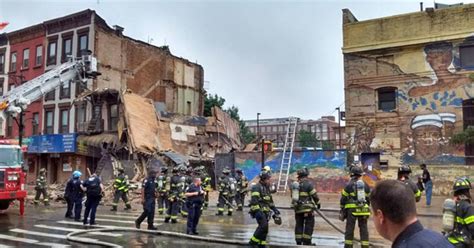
(277, 117, 298, 192)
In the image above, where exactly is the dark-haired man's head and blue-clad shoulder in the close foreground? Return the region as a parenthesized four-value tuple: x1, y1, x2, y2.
(370, 180, 453, 248)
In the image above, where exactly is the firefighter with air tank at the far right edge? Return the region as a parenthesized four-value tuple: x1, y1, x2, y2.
(443, 178, 474, 248)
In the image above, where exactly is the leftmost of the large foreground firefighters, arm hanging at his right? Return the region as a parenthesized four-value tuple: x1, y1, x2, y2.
(249, 171, 281, 247)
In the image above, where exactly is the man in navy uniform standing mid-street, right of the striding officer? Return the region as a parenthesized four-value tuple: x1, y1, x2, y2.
(184, 177, 205, 235)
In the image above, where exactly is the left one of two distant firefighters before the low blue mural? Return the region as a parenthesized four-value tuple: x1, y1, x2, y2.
(216, 167, 236, 216)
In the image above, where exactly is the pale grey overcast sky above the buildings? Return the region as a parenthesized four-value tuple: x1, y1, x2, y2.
(0, 0, 472, 119)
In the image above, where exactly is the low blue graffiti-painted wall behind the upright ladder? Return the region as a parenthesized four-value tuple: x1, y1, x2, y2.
(234, 150, 349, 192)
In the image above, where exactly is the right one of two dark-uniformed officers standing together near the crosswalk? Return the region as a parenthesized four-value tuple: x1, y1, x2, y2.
(81, 173, 104, 225)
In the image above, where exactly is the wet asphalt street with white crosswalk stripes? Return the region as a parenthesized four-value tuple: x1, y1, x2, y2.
(0, 204, 439, 247)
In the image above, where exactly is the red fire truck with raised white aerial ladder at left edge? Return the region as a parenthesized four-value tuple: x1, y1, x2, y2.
(0, 54, 100, 215)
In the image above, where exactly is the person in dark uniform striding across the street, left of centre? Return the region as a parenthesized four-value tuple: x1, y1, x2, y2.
(135, 169, 157, 230)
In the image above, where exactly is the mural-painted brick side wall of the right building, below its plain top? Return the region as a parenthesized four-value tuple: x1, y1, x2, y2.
(345, 39, 474, 166)
